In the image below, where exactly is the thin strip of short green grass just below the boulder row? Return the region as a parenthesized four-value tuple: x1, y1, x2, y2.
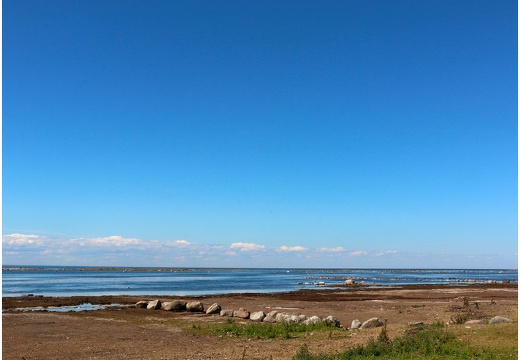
(192, 320, 344, 339)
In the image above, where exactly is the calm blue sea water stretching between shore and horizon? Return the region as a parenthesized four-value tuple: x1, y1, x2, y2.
(2, 266, 518, 296)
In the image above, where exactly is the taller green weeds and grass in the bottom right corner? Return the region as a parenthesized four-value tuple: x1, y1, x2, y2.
(293, 323, 517, 360)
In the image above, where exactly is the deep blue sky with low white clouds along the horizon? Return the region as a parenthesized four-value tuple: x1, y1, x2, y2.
(2, 0, 518, 268)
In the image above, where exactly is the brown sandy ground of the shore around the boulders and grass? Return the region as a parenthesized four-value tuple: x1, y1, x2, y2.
(2, 284, 518, 360)
